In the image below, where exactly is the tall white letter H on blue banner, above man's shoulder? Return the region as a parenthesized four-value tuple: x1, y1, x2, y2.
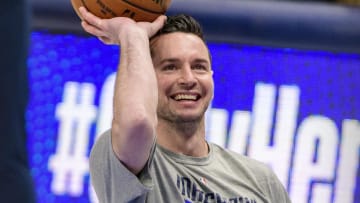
(248, 83, 300, 185)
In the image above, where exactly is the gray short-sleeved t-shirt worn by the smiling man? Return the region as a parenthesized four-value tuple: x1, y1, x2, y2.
(90, 131, 290, 203)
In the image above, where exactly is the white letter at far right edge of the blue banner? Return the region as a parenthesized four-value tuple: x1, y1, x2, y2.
(334, 119, 360, 203)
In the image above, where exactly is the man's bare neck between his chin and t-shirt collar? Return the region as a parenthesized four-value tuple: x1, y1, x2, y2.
(156, 119, 208, 157)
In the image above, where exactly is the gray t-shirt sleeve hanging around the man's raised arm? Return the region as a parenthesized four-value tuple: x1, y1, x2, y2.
(89, 130, 155, 203)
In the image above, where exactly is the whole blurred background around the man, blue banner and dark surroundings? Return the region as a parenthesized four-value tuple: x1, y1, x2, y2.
(0, 0, 360, 203)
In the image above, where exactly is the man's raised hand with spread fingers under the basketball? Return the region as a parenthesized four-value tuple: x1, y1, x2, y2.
(79, 7, 166, 44)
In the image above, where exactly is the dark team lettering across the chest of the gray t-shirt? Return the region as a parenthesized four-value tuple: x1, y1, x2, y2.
(176, 175, 256, 203)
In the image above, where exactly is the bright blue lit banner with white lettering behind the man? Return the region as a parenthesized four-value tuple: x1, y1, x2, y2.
(26, 0, 360, 203)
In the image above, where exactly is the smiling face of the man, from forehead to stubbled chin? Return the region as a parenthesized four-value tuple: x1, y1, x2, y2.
(152, 32, 214, 122)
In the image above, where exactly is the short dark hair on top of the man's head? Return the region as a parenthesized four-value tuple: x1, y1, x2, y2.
(152, 14, 205, 42)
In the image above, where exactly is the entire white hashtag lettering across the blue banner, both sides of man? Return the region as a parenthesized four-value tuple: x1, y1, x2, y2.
(48, 79, 360, 203)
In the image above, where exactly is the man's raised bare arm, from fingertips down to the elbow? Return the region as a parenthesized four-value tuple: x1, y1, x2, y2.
(80, 8, 166, 174)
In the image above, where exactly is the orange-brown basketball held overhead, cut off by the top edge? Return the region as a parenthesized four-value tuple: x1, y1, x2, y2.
(71, 0, 171, 22)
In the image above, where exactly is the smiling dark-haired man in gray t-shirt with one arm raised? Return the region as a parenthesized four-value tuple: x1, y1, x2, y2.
(80, 8, 290, 203)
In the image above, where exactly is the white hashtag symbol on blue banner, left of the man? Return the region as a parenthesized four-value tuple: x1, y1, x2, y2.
(48, 82, 97, 197)
